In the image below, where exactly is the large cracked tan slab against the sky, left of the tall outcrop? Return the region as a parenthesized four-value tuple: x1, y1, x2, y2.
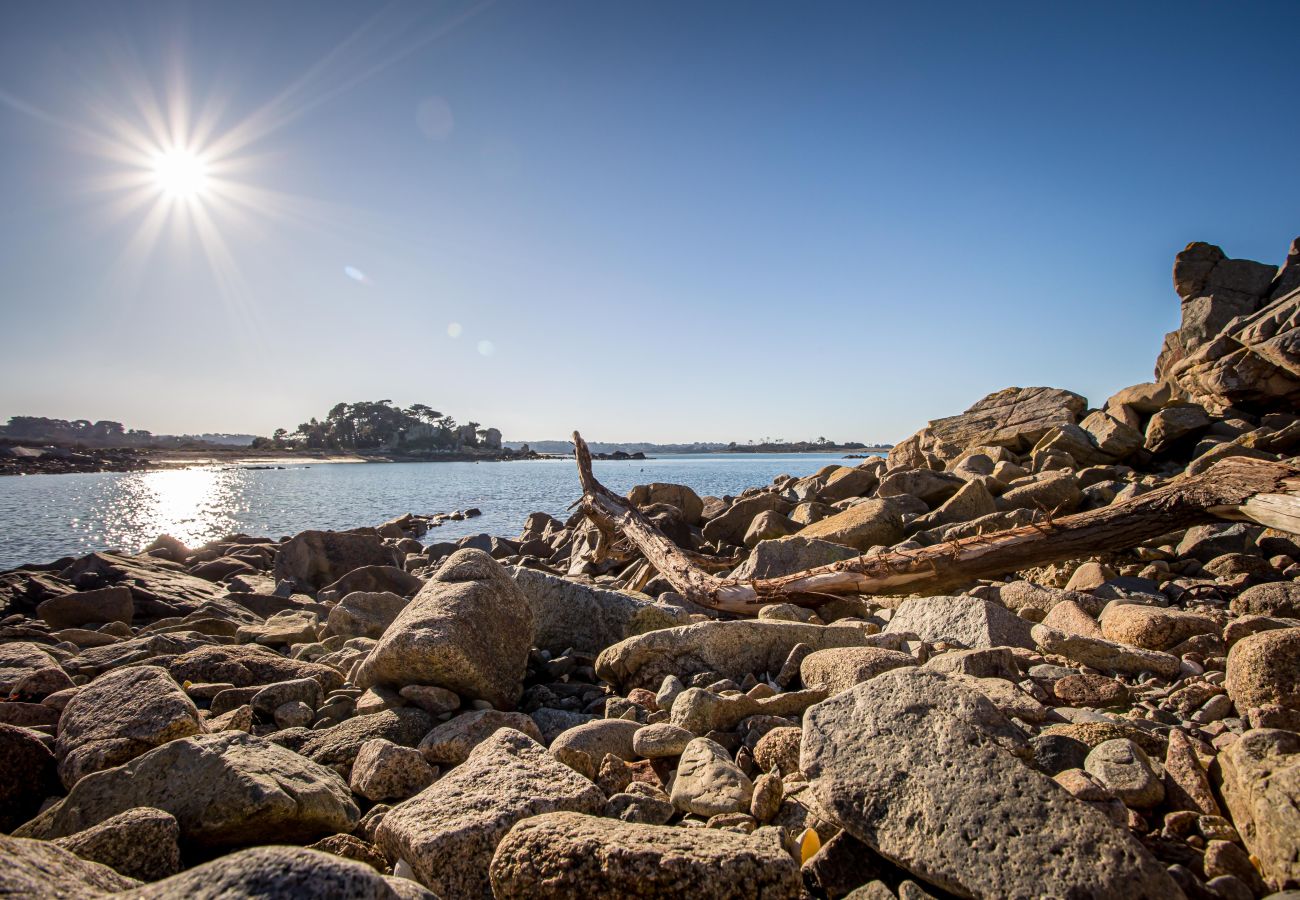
(889, 388, 1088, 468)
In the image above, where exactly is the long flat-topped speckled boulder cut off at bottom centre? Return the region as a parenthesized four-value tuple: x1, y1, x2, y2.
(490, 813, 800, 900)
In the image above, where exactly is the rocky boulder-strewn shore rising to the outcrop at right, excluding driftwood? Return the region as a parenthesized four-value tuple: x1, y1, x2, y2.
(0, 235, 1300, 900)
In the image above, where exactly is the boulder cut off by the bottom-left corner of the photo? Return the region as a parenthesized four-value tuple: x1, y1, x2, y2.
(0, 835, 139, 900)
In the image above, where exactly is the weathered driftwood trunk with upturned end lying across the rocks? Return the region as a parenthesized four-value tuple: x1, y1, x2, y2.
(573, 432, 1300, 615)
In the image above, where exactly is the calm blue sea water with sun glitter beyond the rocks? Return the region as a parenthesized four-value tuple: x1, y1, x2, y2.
(0, 453, 878, 570)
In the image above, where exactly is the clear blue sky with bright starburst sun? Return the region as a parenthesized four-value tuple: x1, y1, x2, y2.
(0, 0, 1300, 441)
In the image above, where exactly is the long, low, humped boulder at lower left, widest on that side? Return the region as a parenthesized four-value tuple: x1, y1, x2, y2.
(16, 731, 360, 851)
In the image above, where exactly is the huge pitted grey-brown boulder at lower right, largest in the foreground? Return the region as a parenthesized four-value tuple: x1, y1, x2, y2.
(801, 670, 1182, 899)
